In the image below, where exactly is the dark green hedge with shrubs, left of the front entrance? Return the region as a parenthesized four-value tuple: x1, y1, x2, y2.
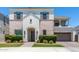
(5, 34, 23, 43)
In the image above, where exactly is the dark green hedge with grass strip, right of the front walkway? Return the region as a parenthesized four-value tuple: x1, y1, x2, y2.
(32, 35, 64, 47)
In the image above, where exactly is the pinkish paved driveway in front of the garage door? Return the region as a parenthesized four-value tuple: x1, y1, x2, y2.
(57, 42, 79, 52)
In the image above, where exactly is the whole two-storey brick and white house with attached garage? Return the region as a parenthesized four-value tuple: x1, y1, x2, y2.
(9, 8, 76, 42)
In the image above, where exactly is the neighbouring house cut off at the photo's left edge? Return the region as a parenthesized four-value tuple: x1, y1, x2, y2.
(0, 13, 9, 42)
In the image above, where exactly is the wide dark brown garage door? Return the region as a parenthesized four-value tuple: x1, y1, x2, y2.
(54, 33, 71, 41)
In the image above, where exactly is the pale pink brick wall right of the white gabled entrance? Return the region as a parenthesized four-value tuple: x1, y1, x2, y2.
(39, 20, 54, 35)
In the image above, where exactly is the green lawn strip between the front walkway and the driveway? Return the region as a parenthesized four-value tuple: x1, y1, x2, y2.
(32, 43, 64, 47)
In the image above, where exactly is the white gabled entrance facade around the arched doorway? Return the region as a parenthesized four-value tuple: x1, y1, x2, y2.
(23, 14, 39, 42)
